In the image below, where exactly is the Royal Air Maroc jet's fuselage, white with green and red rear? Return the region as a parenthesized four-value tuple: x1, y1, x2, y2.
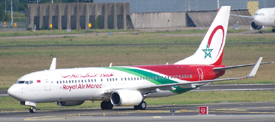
(9, 65, 224, 102)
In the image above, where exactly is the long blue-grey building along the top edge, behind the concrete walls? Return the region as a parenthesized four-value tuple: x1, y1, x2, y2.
(94, 0, 275, 13)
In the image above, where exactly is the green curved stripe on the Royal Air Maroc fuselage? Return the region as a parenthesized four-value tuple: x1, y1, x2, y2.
(108, 67, 178, 85)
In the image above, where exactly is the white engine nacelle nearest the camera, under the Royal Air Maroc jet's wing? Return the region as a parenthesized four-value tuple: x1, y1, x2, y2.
(110, 90, 143, 106)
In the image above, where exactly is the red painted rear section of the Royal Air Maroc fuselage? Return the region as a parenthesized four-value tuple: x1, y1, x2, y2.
(132, 65, 225, 81)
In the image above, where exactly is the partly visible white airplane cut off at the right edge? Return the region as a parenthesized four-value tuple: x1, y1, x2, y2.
(231, 8, 275, 33)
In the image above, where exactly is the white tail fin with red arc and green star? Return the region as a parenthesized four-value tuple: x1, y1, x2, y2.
(175, 6, 231, 65)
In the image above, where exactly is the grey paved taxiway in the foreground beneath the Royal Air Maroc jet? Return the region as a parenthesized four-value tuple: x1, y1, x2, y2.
(0, 102, 275, 122)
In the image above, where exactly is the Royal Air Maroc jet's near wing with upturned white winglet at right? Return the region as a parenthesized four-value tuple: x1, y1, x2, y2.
(104, 57, 262, 94)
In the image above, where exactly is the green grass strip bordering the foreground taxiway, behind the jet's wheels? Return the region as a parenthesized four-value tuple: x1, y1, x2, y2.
(0, 91, 275, 111)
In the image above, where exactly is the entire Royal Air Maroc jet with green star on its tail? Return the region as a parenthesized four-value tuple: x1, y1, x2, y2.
(8, 6, 270, 113)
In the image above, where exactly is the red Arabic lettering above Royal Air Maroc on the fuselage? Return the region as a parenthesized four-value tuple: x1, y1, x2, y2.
(61, 73, 114, 79)
